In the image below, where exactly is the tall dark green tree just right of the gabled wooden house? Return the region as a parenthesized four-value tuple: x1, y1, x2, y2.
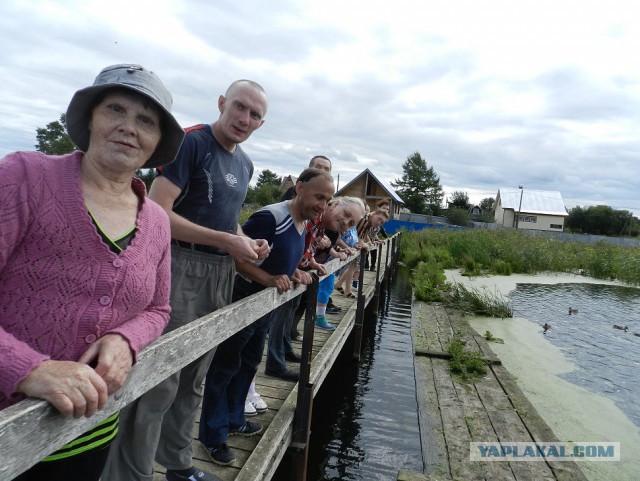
(391, 152, 444, 215)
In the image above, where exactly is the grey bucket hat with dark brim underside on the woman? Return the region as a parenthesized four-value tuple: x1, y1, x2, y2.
(67, 64, 184, 169)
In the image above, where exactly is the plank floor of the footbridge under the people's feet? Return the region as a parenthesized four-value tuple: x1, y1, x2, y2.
(153, 244, 391, 481)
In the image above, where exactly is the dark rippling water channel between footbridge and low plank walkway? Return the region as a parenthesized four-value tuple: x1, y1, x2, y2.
(307, 270, 420, 481)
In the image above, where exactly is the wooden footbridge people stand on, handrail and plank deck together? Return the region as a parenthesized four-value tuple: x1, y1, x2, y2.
(0, 236, 398, 481)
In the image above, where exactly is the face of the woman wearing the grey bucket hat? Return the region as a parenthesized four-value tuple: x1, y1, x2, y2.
(87, 92, 162, 172)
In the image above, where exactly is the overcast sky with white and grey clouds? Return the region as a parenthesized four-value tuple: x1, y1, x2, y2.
(0, 0, 640, 215)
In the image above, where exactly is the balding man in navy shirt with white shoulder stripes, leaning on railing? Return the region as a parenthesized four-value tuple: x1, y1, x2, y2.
(199, 169, 334, 466)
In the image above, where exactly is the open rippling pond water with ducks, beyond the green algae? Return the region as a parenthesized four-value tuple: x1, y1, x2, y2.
(510, 284, 640, 427)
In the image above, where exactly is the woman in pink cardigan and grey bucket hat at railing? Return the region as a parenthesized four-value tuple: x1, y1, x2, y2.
(0, 64, 184, 481)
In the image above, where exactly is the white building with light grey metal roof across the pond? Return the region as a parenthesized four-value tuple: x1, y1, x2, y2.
(494, 188, 569, 232)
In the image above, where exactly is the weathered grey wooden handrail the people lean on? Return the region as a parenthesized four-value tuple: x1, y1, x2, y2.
(0, 237, 397, 480)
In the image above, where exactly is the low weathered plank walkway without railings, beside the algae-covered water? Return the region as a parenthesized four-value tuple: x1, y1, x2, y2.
(398, 301, 586, 481)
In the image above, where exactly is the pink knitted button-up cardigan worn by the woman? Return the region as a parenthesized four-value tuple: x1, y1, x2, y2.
(0, 152, 171, 409)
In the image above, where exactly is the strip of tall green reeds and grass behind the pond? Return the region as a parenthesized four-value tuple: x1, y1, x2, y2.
(400, 229, 640, 301)
